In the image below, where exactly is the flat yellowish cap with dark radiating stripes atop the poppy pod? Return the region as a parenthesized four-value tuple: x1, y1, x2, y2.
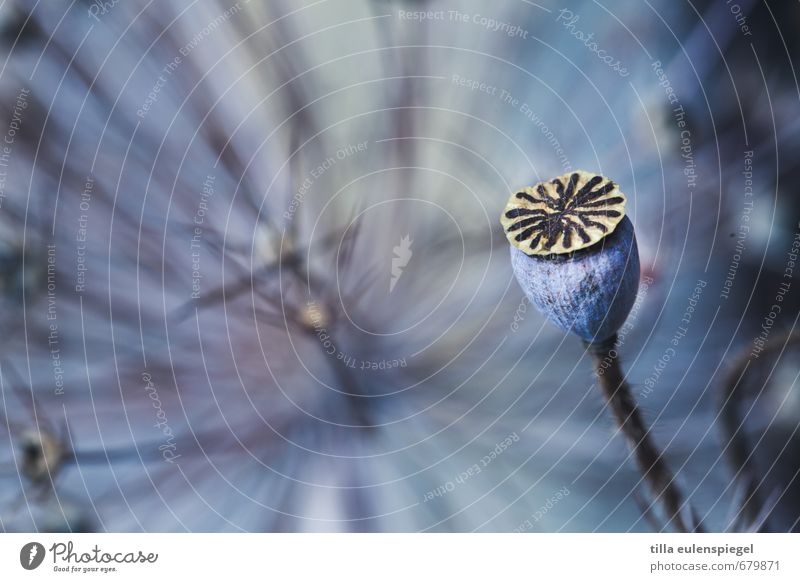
(500, 170, 625, 255)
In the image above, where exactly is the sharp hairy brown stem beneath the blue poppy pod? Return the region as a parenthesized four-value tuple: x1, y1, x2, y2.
(587, 336, 700, 532)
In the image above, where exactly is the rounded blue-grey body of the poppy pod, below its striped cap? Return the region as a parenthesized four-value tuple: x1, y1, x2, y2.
(511, 217, 639, 342)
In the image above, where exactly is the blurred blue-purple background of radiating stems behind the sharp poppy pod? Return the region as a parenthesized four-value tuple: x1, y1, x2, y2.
(0, 0, 800, 532)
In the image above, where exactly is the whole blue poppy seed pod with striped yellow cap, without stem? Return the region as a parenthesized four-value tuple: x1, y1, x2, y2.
(501, 171, 639, 343)
